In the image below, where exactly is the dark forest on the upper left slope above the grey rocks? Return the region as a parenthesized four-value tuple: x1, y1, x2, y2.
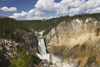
(0, 17, 30, 42)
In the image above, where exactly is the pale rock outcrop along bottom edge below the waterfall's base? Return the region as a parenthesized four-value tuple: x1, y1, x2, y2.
(39, 60, 81, 67)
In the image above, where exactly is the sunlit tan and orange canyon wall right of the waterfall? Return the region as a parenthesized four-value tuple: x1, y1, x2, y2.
(45, 18, 100, 66)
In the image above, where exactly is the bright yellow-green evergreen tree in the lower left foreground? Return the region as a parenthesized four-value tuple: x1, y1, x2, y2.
(9, 49, 29, 67)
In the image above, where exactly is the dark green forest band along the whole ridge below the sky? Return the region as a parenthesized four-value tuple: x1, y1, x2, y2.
(0, 13, 100, 42)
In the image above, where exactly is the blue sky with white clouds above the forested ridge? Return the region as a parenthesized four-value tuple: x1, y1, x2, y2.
(0, 0, 100, 20)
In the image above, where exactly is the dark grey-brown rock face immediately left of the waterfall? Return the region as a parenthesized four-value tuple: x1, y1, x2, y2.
(15, 30, 39, 54)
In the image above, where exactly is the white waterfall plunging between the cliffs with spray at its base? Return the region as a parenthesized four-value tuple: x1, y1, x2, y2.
(36, 33, 60, 63)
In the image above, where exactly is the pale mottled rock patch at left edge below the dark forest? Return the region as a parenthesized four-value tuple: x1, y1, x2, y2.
(0, 39, 23, 61)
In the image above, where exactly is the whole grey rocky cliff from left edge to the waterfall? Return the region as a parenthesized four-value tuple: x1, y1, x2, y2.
(0, 30, 39, 61)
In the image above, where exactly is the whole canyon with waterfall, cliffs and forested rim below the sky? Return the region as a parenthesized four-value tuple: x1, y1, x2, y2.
(0, 14, 100, 67)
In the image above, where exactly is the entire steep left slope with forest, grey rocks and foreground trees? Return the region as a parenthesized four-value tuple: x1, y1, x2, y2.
(0, 17, 40, 67)
